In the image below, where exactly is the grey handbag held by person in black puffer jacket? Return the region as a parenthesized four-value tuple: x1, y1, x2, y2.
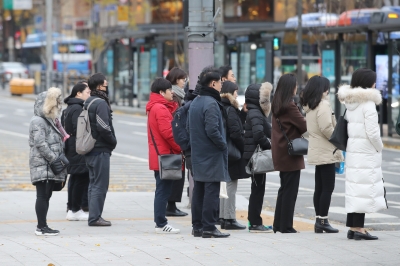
(246, 145, 275, 176)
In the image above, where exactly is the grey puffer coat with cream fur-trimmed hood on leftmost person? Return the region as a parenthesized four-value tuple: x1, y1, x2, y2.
(29, 88, 67, 184)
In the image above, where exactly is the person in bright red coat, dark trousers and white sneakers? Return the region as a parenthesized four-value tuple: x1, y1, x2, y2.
(146, 78, 181, 234)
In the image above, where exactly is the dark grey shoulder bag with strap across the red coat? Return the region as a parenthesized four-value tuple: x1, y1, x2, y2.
(149, 125, 184, 180)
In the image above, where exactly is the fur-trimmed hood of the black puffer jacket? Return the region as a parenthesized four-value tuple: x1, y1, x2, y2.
(245, 82, 273, 116)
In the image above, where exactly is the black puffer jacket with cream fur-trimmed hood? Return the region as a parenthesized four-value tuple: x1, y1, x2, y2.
(243, 82, 272, 161)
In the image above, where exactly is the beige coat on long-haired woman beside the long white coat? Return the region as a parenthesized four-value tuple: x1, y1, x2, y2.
(303, 99, 343, 165)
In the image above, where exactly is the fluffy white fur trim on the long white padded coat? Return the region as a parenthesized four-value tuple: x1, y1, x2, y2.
(337, 85, 382, 108)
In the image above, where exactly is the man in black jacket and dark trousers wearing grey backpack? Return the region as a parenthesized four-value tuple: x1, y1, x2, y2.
(84, 73, 117, 226)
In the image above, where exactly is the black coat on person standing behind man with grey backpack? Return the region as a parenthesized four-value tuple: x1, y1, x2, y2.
(61, 98, 89, 175)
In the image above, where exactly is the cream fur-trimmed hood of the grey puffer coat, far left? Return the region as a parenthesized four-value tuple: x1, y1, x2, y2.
(34, 87, 62, 121)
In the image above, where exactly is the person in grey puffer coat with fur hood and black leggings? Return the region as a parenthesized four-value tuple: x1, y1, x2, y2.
(29, 88, 67, 236)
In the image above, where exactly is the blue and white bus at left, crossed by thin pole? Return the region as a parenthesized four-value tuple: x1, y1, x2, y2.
(22, 33, 92, 75)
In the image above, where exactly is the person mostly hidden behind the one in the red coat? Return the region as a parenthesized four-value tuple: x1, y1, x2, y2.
(165, 67, 188, 216)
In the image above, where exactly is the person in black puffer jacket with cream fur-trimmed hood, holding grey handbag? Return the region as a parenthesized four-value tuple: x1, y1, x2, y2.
(243, 82, 272, 233)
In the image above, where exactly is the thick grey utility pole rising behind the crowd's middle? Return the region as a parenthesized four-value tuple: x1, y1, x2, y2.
(186, 0, 218, 90)
